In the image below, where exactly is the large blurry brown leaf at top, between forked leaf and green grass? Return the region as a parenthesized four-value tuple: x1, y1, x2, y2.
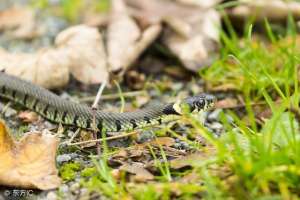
(126, 0, 220, 71)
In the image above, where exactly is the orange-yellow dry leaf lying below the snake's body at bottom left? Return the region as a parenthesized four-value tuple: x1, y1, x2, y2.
(0, 121, 61, 190)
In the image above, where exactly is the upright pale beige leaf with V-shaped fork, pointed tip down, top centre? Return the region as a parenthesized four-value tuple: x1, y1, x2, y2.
(107, 0, 161, 76)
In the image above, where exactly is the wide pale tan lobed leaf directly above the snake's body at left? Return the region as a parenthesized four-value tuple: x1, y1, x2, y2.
(0, 25, 108, 89)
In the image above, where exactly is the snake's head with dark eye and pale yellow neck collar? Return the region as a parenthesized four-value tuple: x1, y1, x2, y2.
(173, 94, 216, 114)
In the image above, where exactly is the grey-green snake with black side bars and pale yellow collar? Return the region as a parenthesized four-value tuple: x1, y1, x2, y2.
(0, 72, 215, 132)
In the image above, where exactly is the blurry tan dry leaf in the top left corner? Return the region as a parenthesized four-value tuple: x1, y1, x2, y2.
(0, 7, 41, 39)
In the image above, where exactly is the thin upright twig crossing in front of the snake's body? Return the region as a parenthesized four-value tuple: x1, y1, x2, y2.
(92, 81, 107, 156)
